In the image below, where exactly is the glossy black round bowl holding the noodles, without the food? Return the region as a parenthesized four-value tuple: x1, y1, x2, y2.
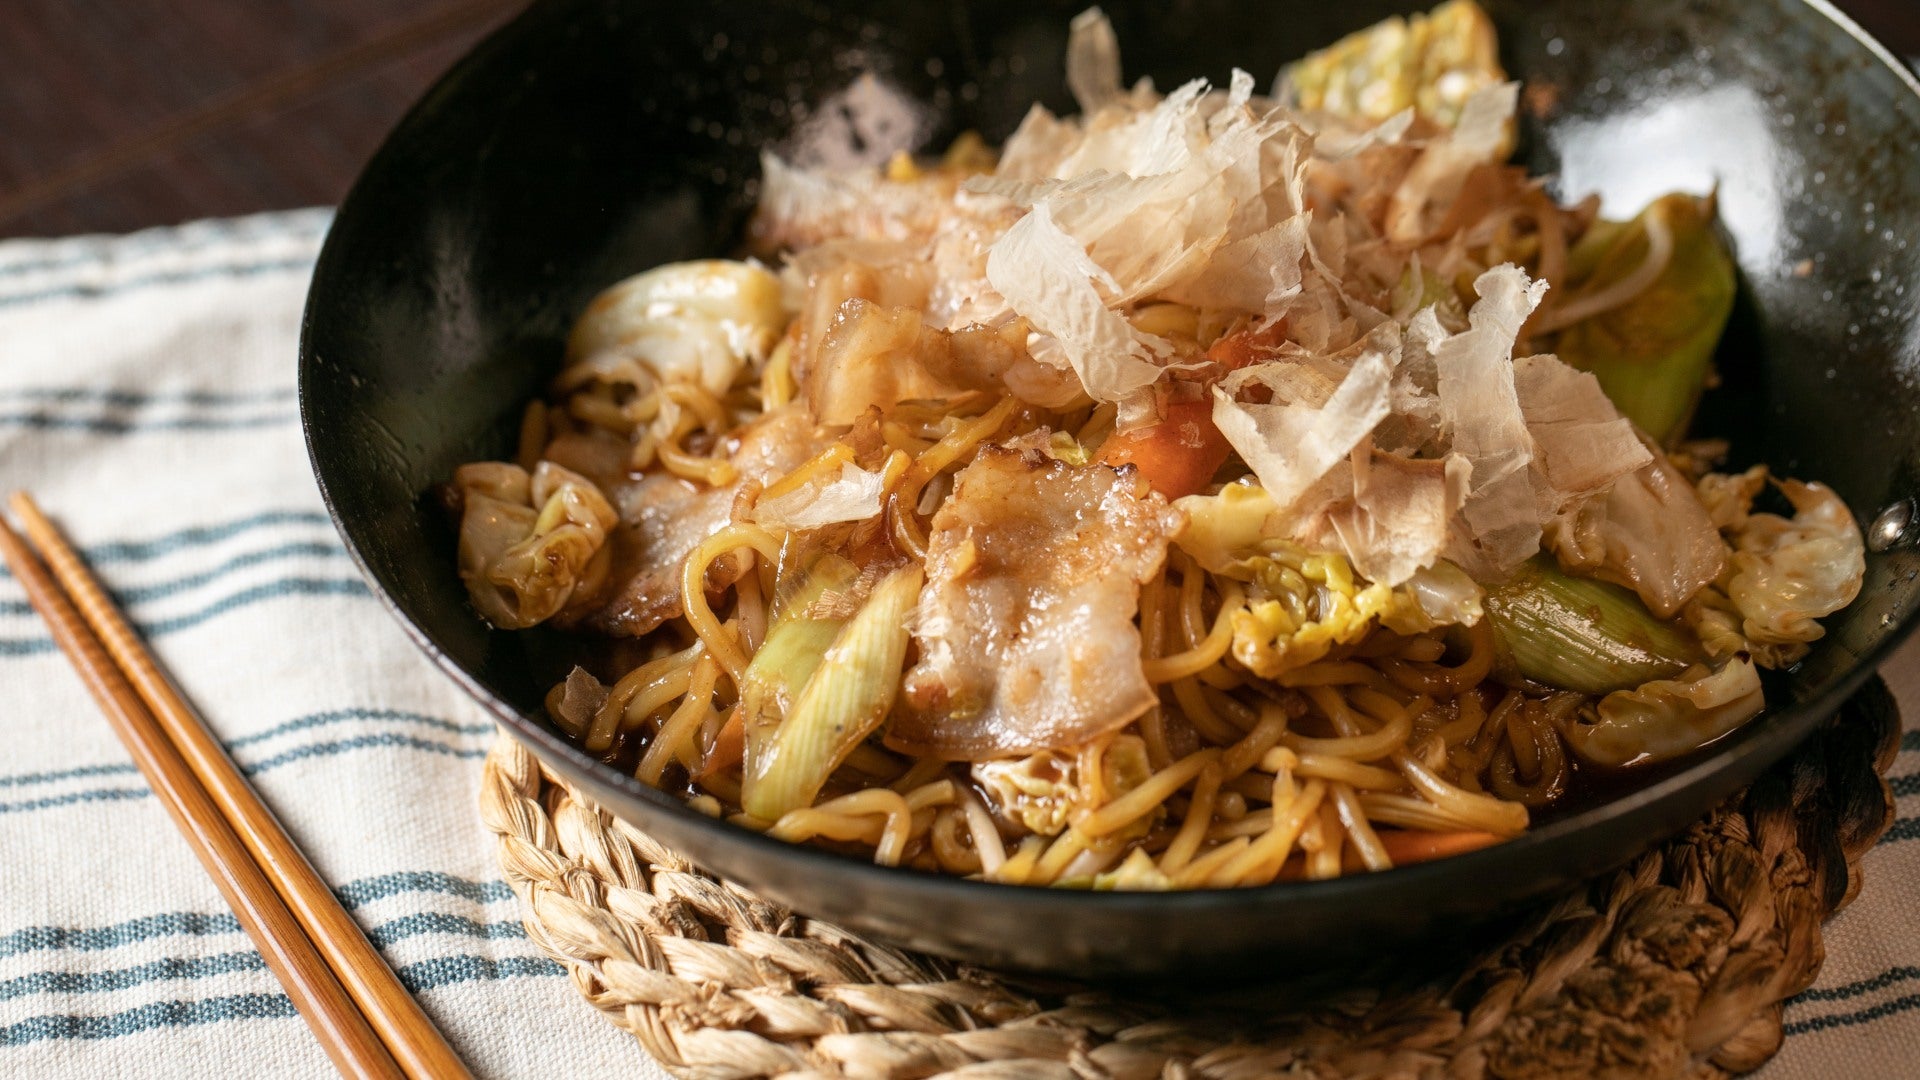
(300, 0, 1920, 974)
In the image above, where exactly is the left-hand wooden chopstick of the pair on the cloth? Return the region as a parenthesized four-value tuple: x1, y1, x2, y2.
(0, 519, 405, 1080)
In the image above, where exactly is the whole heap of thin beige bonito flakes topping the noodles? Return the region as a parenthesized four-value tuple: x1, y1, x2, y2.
(760, 10, 1651, 586)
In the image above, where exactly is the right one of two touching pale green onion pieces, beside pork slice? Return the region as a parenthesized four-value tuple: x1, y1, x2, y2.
(739, 567, 924, 821)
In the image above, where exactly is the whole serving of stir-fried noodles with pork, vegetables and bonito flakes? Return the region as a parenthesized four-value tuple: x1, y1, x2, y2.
(451, 0, 1862, 888)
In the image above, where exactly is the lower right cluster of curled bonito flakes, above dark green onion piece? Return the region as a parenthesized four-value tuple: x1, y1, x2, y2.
(1213, 265, 1589, 584)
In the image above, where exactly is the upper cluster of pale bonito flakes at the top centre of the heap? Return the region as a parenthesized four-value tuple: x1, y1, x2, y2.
(964, 12, 1309, 402)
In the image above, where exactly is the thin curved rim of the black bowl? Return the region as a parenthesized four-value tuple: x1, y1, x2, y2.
(298, 0, 1920, 917)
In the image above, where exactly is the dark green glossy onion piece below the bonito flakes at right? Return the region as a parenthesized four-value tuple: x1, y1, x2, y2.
(1486, 555, 1703, 694)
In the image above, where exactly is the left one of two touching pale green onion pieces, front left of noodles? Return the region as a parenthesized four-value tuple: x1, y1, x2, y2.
(739, 555, 860, 795)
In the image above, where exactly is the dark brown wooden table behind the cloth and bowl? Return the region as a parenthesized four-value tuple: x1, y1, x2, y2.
(0, 0, 1920, 236)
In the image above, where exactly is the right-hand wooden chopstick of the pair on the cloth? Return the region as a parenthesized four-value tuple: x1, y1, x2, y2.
(12, 492, 468, 1080)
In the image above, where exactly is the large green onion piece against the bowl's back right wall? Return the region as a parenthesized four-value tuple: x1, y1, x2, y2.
(1553, 194, 1736, 446)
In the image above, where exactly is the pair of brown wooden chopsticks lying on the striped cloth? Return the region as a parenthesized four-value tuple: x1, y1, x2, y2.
(0, 492, 468, 1080)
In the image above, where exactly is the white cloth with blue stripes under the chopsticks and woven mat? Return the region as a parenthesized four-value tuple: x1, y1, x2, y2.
(0, 211, 1920, 1080)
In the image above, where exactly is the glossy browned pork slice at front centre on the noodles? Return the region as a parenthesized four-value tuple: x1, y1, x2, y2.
(887, 448, 1181, 761)
